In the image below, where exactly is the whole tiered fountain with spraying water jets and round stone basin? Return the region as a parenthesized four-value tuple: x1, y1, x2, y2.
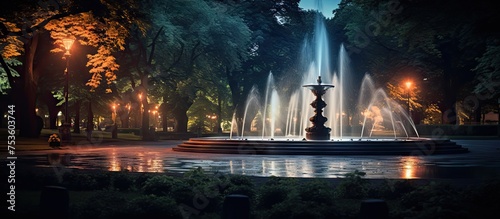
(173, 6, 468, 155)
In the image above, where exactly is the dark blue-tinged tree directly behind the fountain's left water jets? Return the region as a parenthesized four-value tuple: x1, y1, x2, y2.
(225, 0, 302, 125)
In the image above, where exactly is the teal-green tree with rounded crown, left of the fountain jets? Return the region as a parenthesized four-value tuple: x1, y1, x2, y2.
(147, 0, 250, 132)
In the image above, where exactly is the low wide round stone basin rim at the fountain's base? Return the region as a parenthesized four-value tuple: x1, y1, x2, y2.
(173, 137, 469, 156)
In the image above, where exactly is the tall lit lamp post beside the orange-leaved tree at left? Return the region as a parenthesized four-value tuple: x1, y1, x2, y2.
(61, 38, 75, 142)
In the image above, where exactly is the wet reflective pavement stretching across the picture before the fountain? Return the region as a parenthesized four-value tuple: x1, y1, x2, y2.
(10, 140, 500, 179)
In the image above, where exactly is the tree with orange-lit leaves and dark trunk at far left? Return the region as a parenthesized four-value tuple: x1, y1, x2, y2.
(0, 0, 145, 137)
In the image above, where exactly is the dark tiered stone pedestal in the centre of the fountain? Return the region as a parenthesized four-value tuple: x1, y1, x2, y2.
(303, 76, 334, 140)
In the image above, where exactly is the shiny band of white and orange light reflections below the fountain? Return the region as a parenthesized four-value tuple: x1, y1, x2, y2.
(37, 151, 426, 179)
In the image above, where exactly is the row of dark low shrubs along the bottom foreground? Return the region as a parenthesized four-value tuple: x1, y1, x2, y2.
(14, 168, 500, 218)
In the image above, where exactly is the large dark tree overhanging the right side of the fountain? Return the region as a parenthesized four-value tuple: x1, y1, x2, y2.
(335, 0, 499, 124)
